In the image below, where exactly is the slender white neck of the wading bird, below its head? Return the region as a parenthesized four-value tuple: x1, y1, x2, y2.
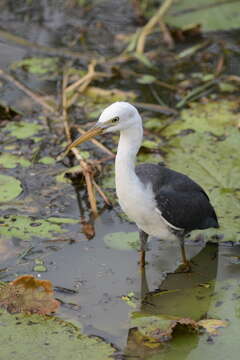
(115, 123, 143, 191)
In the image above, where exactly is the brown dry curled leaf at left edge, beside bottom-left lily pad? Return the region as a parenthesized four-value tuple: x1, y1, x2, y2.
(0, 275, 60, 315)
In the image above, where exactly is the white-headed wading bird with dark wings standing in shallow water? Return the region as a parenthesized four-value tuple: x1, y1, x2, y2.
(62, 101, 219, 269)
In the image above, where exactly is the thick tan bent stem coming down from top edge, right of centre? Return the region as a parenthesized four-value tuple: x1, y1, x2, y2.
(136, 0, 173, 54)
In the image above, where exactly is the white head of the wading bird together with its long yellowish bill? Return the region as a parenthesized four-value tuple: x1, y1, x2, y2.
(64, 101, 142, 154)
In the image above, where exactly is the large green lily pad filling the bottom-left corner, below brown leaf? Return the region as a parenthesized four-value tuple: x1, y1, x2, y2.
(0, 310, 114, 360)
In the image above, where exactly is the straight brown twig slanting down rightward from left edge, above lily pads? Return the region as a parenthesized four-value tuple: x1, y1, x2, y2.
(0, 69, 56, 113)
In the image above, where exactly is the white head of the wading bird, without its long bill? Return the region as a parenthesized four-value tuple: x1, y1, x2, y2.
(96, 101, 142, 133)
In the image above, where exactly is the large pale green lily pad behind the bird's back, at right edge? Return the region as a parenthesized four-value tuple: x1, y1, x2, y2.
(166, 130, 240, 241)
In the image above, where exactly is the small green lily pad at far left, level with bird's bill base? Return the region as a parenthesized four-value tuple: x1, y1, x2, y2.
(4, 121, 43, 139)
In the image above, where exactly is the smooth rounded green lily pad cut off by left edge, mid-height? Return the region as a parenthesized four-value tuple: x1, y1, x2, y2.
(0, 174, 22, 202)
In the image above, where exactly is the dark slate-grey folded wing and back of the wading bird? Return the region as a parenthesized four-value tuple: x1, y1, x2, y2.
(136, 164, 219, 231)
